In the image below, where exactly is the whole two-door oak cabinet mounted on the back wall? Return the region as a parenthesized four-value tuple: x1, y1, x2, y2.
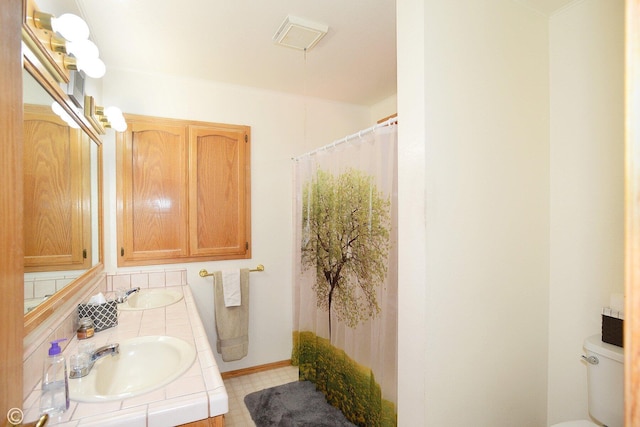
(117, 115, 251, 266)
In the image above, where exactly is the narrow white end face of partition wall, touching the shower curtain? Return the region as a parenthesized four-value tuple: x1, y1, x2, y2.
(396, 0, 430, 426)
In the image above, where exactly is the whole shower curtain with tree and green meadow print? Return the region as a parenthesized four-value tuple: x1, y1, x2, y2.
(292, 124, 398, 427)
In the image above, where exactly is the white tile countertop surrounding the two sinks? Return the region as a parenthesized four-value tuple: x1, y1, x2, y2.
(24, 285, 229, 427)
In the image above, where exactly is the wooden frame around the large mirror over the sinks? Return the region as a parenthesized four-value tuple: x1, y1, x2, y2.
(22, 0, 104, 336)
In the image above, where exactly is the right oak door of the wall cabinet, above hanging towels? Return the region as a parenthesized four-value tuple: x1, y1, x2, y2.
(189, 126, 251, 259)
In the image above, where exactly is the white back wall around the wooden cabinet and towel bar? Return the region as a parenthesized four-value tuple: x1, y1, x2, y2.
(99, 69, 372, 372)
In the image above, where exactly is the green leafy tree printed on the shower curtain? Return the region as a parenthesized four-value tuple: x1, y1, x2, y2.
(302, 169, 391, 339)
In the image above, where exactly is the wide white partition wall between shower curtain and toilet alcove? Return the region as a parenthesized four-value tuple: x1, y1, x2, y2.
(397, 0, 549, 427)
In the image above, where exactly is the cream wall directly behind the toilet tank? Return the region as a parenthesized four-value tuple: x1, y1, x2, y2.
(548, 0, 624, 424)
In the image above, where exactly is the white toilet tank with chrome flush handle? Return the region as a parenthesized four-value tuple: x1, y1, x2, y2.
(584, 335, 624, 427)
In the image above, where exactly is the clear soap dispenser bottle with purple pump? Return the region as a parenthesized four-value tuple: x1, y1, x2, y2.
(40, 338, 69, 415)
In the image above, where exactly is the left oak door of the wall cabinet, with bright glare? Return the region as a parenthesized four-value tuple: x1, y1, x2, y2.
(118, 118, 187, 265)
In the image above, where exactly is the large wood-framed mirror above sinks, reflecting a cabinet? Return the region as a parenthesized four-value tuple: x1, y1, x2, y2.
(22, 0, 103, 334)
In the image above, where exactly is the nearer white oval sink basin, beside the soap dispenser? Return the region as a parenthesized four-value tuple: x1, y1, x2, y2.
(69, 336, 196, 402)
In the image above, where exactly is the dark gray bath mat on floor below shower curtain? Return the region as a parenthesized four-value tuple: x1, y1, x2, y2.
(244, 381, 355, 427)
